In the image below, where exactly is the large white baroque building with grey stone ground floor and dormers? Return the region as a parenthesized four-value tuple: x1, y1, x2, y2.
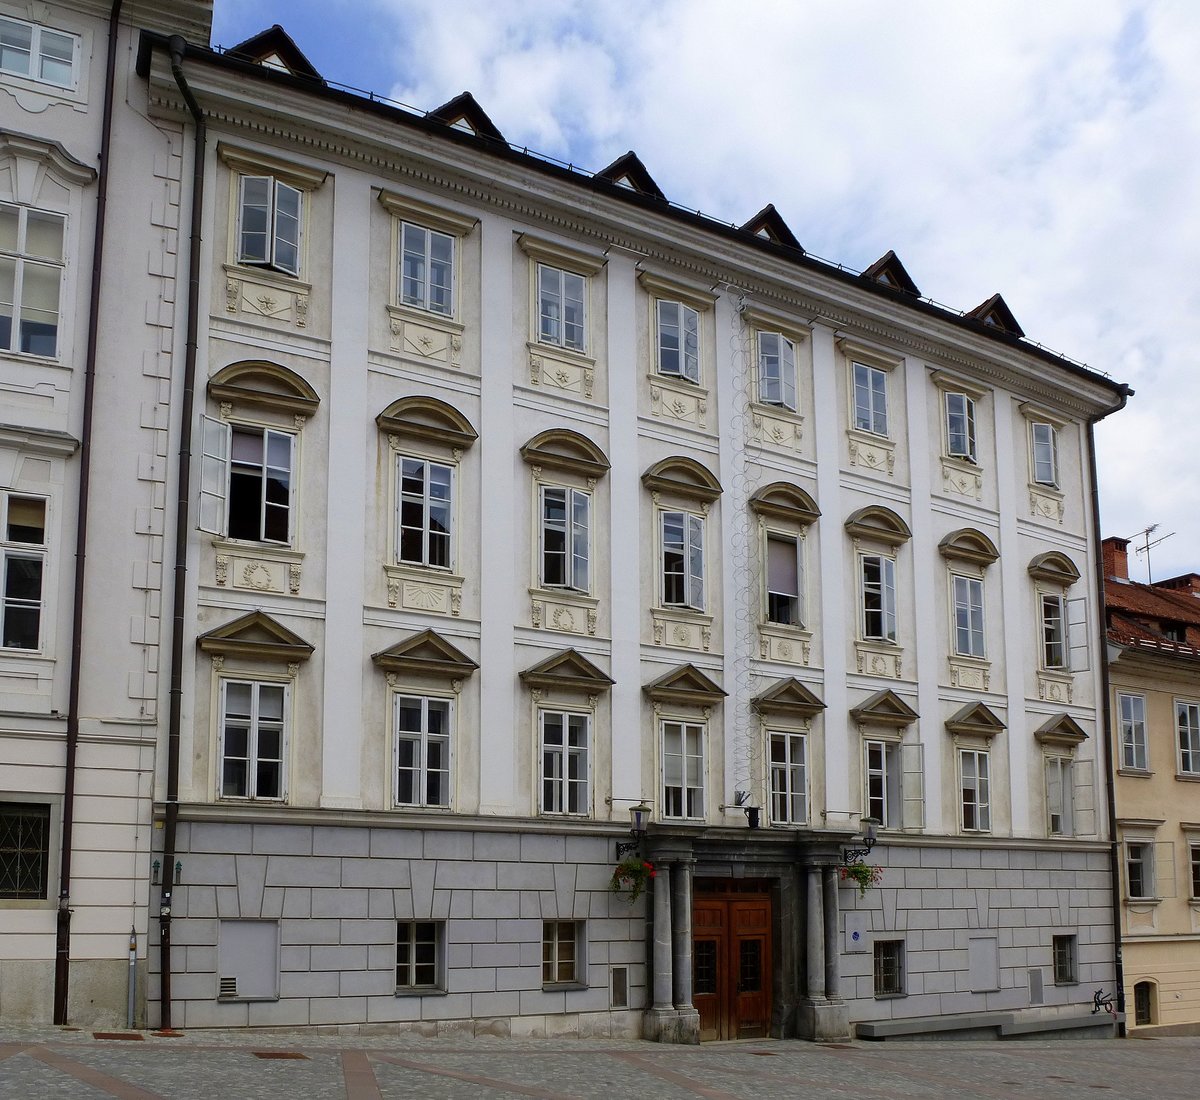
(0, 5, 1128, 1042)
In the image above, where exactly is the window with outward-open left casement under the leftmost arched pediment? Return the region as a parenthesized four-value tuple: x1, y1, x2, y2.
(199, 416, 296, 546)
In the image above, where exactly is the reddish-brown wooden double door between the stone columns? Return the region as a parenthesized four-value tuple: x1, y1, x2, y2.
(691, 879, 773, 1041)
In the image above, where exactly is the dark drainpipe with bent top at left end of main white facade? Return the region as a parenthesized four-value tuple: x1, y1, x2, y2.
(158, 35, 206, 1030)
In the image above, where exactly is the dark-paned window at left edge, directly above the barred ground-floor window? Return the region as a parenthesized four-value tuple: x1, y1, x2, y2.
(0, 491, 46, 650)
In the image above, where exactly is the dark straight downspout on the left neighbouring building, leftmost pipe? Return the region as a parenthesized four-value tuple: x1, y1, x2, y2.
(54, 0, 122, 1026)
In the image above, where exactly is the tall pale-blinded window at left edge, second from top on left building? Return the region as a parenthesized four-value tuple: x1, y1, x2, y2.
(0, 203, 66, 359)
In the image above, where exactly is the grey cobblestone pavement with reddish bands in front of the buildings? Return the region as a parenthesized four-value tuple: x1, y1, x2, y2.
(0, 1028, 1200, 1100)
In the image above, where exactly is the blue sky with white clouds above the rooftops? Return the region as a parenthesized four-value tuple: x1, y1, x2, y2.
(212, 0, 1200, 581)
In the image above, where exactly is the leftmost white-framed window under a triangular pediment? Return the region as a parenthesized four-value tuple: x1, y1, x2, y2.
(220, 680, 289, 800)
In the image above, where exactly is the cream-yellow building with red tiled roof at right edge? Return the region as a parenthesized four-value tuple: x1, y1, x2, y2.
(1104, 539, 1200, 1029)
